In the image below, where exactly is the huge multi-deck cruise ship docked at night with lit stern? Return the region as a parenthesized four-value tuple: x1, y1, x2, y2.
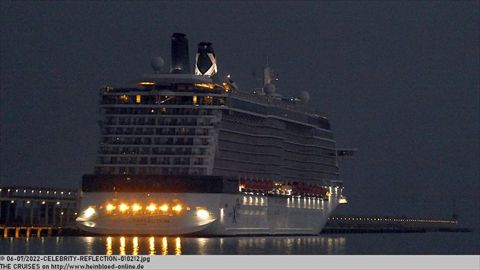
(77, 33, 344, 235)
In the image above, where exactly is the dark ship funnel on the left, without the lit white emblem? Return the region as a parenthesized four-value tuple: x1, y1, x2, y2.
(170, 33, 190, 73)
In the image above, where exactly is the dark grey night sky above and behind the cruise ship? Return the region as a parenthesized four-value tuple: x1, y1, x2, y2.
(0, 1, 480, 230)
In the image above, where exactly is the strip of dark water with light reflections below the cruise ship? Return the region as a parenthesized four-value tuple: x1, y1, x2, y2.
(0, 232, 480, 255)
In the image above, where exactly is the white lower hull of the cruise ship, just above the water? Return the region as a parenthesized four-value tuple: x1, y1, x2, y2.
(77, 192, 339, 235)
